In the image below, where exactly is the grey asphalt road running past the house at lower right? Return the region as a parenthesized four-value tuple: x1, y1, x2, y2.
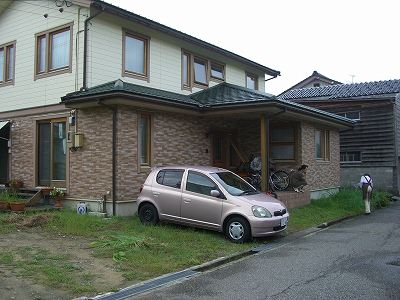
(134, 201, 400, 300)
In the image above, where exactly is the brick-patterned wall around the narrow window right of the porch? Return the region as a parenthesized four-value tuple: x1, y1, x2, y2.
(301, 123, 340, 190)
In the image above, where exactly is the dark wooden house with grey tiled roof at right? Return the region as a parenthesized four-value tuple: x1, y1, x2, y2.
(279, 80, 400, 193)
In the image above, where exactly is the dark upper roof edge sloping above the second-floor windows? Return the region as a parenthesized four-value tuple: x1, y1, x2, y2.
(92, 0, 280, 77)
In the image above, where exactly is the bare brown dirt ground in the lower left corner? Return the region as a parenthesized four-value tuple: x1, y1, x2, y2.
(0, 227, 124, 300)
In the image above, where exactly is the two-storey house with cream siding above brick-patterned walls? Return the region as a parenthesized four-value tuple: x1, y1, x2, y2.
(0, 0, 352, 215)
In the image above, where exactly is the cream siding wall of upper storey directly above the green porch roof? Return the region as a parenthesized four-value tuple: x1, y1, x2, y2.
(88, 14, 265, 94)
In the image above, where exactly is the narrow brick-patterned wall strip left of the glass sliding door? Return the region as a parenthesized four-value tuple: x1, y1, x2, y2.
(10, 117, 36, 188)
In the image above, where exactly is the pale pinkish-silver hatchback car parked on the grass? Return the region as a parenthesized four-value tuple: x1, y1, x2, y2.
(138, 166, 289, 243)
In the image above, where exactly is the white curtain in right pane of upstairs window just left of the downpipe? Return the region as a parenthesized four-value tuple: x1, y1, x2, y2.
(51, 30, 70, 69)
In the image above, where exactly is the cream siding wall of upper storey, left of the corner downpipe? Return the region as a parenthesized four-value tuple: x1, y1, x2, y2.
(0, 0, 87, 112)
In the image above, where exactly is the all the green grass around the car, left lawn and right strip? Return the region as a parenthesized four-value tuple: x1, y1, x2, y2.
(0, 189, 390, 295)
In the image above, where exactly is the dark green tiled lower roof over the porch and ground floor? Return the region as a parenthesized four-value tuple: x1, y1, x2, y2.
(61, 79, 354, 127)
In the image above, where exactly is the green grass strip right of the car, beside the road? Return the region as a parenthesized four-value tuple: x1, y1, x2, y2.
(288, 188, 390, 233)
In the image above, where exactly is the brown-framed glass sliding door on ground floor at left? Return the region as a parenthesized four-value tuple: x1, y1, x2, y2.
(38, 119, 67, 187)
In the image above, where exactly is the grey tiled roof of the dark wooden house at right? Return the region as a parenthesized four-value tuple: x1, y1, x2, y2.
(279, 79, 400, 100)
